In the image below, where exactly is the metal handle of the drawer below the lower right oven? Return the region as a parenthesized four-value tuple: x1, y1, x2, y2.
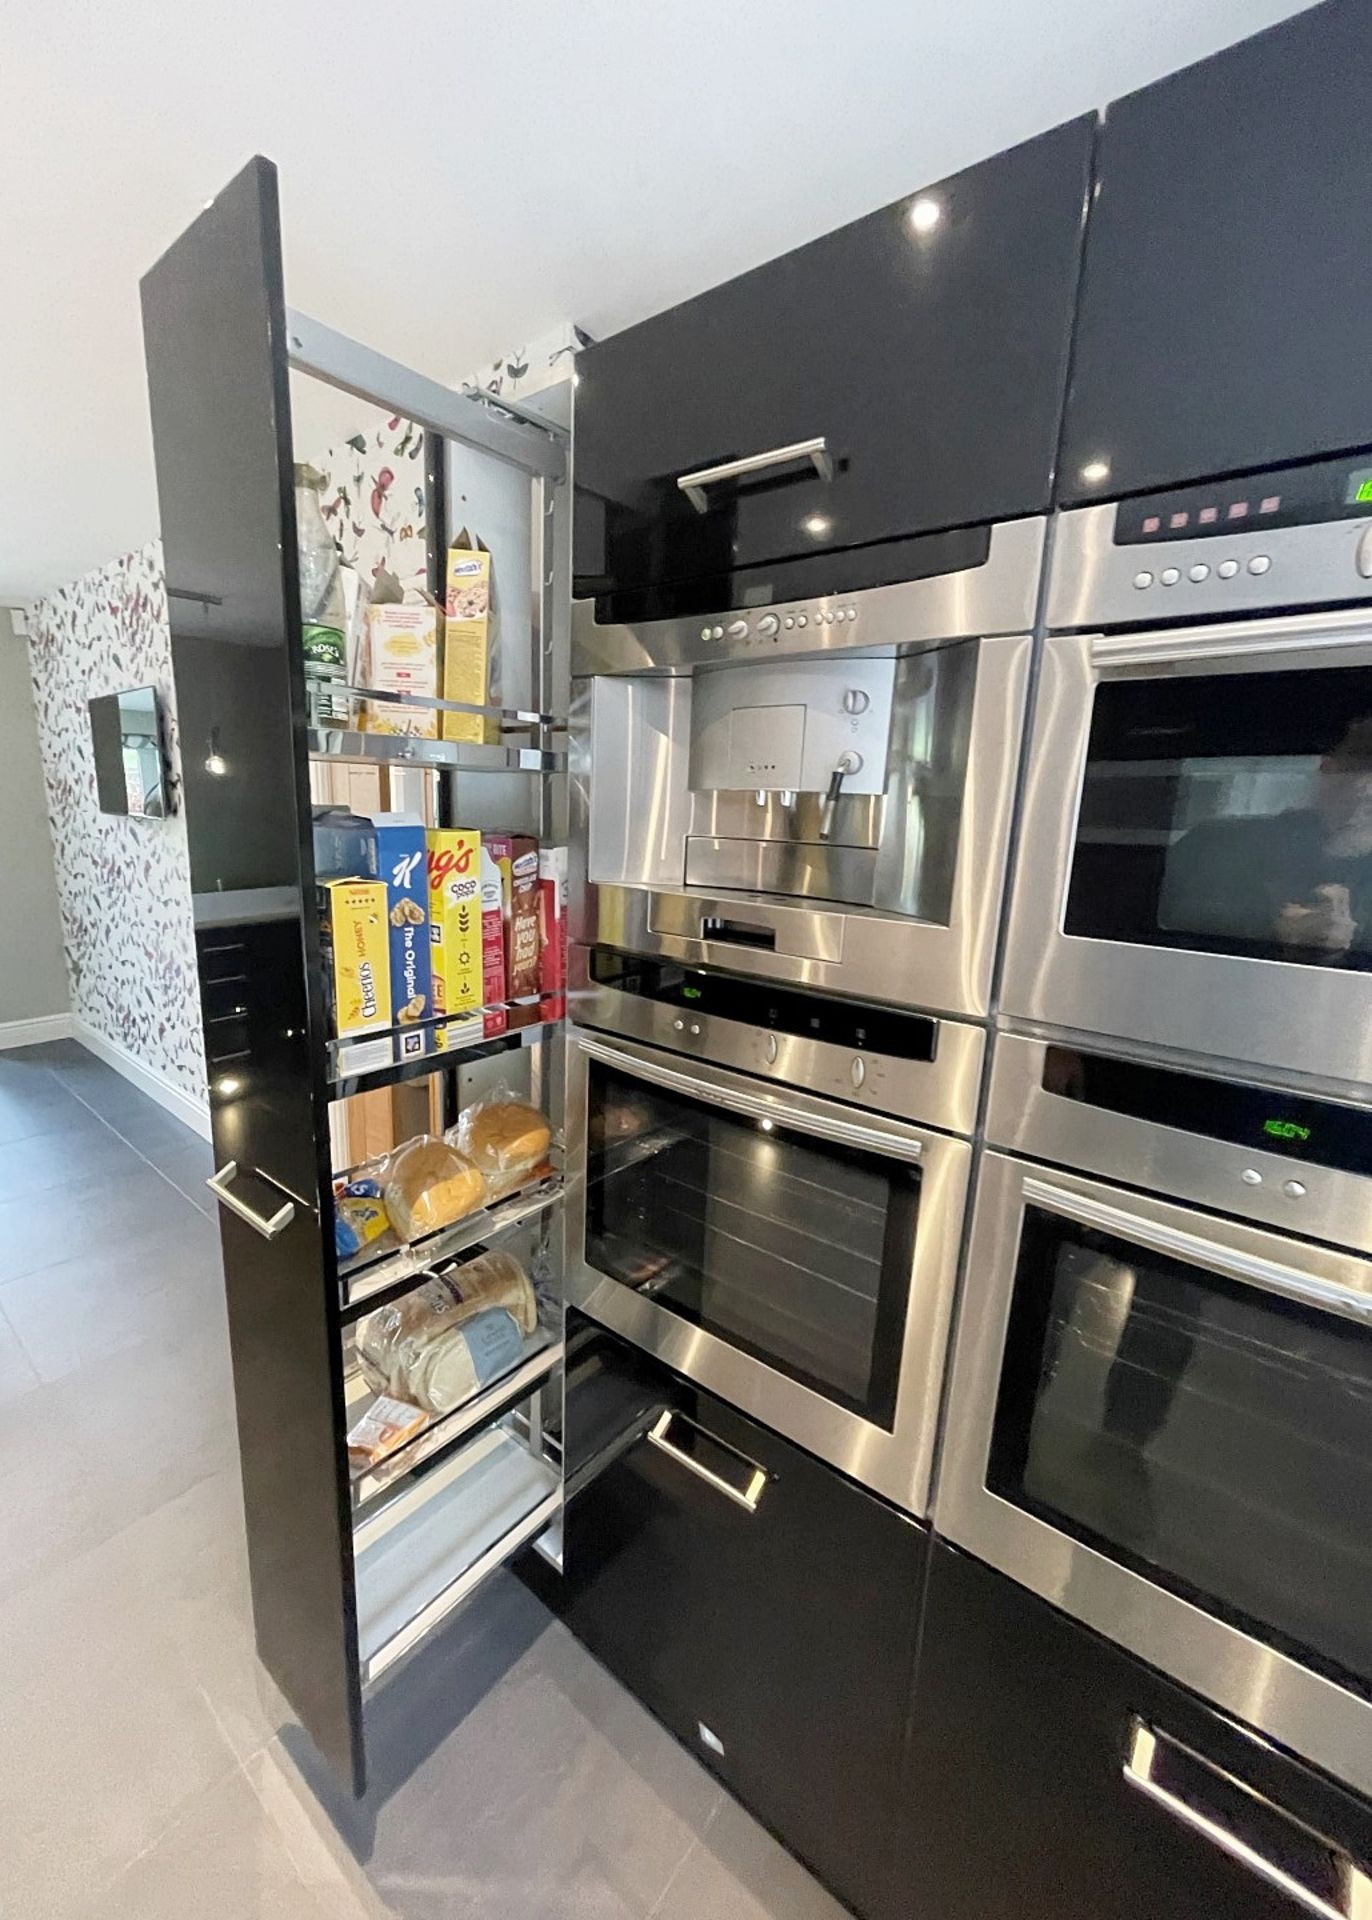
(1124, 1720, 1372, 1920)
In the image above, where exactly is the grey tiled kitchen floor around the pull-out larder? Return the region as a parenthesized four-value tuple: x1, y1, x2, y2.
(0, 1043, 840, 1920)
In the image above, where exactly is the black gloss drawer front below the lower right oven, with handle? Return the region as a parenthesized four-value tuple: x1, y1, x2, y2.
(900, 1542, 1372, 1920)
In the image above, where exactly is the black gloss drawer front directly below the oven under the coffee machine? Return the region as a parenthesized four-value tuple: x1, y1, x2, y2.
(564, 1321, 927, 1916)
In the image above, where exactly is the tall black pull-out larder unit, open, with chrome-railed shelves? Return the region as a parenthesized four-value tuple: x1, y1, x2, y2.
(142, 159, 568, 1791)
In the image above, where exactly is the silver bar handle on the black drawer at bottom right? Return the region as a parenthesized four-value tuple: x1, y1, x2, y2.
(1124, 1720, 1372, 1920)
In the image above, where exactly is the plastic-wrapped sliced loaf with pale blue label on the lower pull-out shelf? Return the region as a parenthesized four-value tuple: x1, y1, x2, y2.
(357, 1254, 539, 1413)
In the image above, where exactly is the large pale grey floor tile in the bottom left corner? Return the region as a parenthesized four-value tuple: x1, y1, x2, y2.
(0, 1540, 238, 1920)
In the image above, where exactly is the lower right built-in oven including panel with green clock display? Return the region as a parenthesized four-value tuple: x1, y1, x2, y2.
(934, 1035, 1372, 1793)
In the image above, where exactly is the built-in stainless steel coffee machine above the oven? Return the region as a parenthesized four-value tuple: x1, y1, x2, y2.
(570, 518, 1044, 1018)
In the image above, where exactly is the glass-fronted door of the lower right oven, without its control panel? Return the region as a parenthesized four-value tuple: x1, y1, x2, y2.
(936, 1154, 1372, 1793)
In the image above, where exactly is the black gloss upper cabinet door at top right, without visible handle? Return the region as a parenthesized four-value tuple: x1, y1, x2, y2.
(1061, 0, 1372, 503)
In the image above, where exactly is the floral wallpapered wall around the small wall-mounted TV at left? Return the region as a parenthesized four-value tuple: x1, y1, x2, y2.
(29, 540, 205, 1098)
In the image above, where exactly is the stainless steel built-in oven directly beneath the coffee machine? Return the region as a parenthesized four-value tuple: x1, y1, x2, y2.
(566, 948, 984, 1515)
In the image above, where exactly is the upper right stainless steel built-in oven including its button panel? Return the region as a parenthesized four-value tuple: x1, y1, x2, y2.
(1002, 455, 1372, 1091)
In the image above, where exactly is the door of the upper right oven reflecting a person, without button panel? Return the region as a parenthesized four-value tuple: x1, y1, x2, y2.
(1002, 612, 1372, 1087)
